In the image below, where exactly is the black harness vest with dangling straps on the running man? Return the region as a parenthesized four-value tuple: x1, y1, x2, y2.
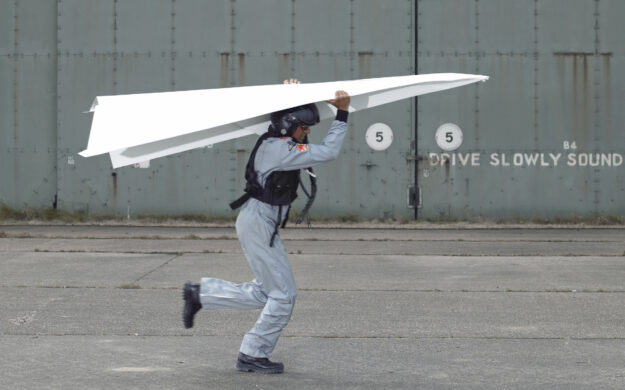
(230, 132, 317, 246)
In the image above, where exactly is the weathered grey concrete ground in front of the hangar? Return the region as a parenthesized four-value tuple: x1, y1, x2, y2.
(0, 225, 625, 389)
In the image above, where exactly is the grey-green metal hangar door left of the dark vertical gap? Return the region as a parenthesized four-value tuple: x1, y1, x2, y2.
(0, 0, 414, 217)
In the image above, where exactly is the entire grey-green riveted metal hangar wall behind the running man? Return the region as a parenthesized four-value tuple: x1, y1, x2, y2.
(0, 0, 625, 219)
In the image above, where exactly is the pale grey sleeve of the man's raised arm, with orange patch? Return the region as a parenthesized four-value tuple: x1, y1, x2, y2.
(277, 120, 347, 171)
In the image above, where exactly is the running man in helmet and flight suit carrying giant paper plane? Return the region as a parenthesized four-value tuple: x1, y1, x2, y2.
(183, 79, 350, 374)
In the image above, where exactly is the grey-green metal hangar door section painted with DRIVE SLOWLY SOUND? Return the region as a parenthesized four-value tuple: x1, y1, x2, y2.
(417, 0, 625, 219)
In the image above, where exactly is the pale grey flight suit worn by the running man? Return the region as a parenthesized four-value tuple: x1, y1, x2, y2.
(200, 120, 347, 358)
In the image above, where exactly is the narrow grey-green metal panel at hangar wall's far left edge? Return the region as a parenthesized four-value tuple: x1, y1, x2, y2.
(0, 1, 56, 208)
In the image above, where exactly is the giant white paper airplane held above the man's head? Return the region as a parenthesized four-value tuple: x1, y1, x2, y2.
(80, 73, 488, 168)
